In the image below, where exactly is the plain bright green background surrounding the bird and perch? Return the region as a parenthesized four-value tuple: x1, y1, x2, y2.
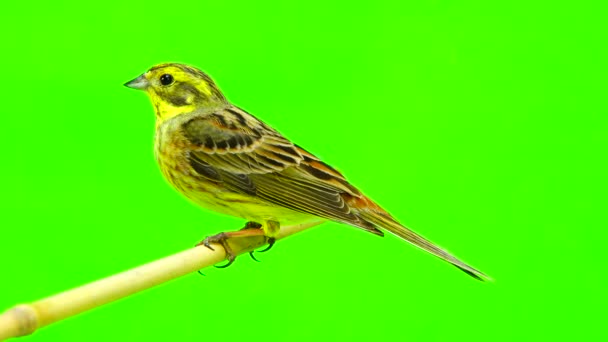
(0, 0, 608, 341)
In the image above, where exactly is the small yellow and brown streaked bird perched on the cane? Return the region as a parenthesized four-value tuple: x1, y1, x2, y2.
(125, 63, 487, 280)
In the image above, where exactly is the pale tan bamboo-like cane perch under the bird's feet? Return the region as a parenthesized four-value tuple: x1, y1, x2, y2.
(0, 222, 321, 341)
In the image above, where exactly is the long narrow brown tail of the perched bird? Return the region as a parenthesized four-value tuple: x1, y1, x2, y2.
(358, 199, 490, 281)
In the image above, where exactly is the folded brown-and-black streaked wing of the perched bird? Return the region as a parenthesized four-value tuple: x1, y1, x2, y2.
(182, 107, 382, 235)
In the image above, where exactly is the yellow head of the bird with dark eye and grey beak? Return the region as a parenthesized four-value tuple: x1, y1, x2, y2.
(125, 63, 227, 122)
